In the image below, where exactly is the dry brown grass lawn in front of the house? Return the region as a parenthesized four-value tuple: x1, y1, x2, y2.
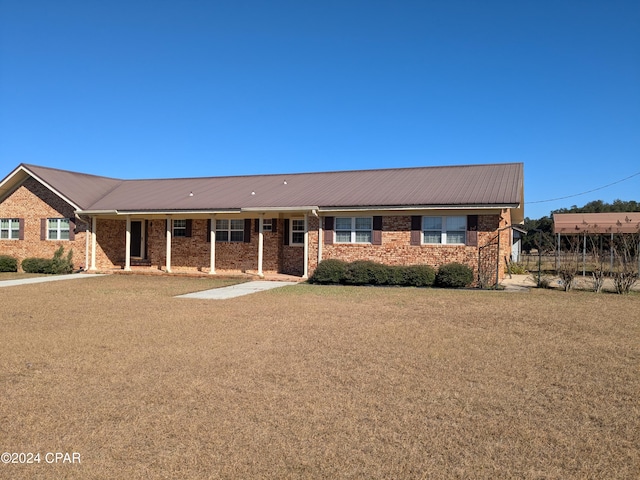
(0, 276, 640, 479)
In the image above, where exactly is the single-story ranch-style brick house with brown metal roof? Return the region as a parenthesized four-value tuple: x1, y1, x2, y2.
(0, 163, 524, 281)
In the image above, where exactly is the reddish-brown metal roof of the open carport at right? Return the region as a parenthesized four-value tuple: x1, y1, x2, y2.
(553, 212, 640, 235)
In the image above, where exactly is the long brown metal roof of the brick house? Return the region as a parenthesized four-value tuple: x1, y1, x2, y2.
(13, 163, 523, 212)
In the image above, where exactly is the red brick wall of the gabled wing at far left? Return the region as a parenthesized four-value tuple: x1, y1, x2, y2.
(0, 178, 87, 270)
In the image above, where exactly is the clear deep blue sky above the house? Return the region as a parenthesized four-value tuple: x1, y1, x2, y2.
(0, 0, 640, 218)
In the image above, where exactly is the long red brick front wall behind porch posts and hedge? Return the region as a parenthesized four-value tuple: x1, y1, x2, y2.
(90, 210, 511, 281)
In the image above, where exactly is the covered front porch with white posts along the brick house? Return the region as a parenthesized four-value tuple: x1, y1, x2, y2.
(86, 214, 316, 279)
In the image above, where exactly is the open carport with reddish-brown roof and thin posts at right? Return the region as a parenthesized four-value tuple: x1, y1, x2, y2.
(553, 212, 640, 275)
